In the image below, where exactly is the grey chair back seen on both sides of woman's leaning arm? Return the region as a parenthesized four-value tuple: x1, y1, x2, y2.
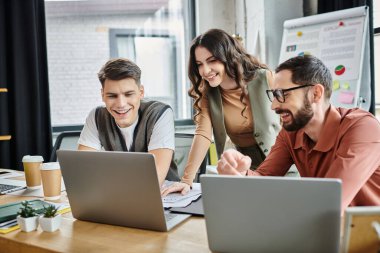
(174, 133, 209, 182)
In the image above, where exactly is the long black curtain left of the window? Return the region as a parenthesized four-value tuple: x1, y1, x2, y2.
(0, 0, 52, 170)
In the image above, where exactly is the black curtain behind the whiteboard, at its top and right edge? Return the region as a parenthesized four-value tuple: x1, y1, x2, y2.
(318, 0, 379, 115)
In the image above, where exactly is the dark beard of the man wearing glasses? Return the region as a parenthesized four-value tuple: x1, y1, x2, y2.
(276, 96, 314, 132)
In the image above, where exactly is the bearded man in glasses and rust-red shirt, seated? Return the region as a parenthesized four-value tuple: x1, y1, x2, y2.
(217, 55, 380, 210)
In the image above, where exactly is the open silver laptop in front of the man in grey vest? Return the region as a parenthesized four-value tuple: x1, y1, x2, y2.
(57, 150, 190, 231)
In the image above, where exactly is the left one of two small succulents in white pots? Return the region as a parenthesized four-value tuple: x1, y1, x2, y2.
(17, 201, 38, 232)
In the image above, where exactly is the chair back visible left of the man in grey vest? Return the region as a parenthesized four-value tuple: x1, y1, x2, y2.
(49, 131, 81, 162)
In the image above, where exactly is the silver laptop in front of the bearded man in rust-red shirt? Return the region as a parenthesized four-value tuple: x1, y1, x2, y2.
(201, 175, 341, 253)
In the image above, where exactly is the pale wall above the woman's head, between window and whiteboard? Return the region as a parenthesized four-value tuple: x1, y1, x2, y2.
(196, 0, 303, 68)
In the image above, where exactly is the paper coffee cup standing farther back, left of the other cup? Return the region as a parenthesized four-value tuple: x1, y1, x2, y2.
(22, 155, 44, 189)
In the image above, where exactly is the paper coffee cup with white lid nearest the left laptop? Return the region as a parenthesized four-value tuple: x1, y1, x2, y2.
(41, 162, 62, 200)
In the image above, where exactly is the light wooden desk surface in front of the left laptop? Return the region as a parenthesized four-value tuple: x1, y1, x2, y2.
(0, 171, 210, 253)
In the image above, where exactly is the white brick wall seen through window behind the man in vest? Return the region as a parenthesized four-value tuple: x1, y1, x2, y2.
(46, 15, 147, 126)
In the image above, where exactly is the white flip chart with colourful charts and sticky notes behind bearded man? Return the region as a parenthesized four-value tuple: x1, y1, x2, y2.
(280, 6, 371, 111)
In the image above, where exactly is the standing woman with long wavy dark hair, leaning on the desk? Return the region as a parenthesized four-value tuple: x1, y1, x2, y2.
(162, 29, 281, 195)
